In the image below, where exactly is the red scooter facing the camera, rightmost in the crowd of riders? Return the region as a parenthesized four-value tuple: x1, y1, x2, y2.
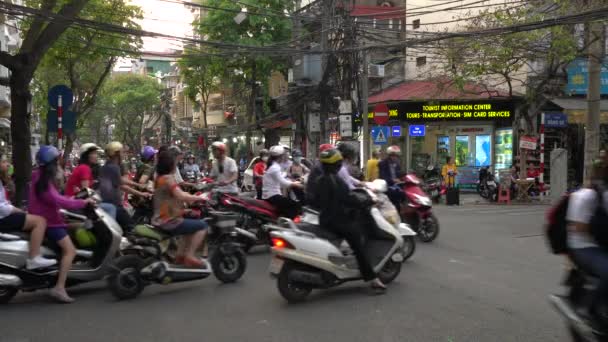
(398, 174, 439, 242)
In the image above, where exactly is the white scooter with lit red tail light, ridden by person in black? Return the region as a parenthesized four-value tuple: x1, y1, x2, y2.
(268, 189, 404, 303)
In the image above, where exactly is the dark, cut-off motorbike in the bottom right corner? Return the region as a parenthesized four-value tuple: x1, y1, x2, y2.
(549, 267, 608, 342)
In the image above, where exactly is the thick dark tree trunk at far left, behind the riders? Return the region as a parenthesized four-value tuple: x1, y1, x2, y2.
(11, 74, 32, 207)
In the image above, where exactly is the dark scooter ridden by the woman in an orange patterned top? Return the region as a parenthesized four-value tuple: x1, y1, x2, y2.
(107, 211, 247, 300)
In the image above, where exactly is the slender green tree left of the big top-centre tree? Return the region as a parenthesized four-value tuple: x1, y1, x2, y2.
(178, 47, 222, 128)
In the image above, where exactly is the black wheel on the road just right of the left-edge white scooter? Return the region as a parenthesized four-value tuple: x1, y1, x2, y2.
(108, 254, 145, 300)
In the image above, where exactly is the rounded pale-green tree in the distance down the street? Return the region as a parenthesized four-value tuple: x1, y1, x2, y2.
(97, 74, 161, 151)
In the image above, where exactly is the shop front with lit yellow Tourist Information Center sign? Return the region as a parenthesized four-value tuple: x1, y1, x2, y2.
(370, 100, 514, 190)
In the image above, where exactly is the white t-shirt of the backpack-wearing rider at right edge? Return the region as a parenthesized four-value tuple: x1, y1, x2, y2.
(566, 189, 608, 249)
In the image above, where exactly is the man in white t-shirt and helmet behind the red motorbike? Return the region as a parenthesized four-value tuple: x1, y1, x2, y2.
(210, 141, 239, 194)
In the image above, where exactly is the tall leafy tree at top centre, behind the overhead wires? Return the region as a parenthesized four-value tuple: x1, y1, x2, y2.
(194, 0, 294, 147)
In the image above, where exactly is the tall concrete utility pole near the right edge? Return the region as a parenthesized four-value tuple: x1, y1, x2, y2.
(584, 22, 605, 182)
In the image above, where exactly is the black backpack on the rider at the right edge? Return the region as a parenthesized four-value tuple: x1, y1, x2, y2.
(545, 194, 570, 254)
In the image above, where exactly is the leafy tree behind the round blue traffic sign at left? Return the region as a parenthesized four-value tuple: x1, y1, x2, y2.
(34, 0, 142, 155)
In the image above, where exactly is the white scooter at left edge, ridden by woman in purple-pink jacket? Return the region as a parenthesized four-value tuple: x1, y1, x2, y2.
(0, 189, 124, 303)
